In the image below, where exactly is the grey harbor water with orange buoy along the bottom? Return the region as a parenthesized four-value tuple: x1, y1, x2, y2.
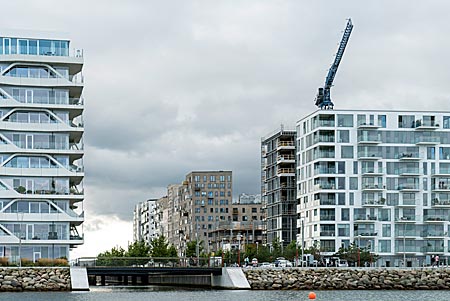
(0, 286, 450, 301)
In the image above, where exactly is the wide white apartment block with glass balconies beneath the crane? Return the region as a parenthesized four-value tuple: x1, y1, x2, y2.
(297, 110, 450, 266)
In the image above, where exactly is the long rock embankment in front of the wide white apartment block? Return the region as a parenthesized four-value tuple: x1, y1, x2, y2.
(244, 268, 450, 290)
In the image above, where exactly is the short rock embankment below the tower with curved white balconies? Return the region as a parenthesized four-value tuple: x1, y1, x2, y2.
(0, 268, 71, 292)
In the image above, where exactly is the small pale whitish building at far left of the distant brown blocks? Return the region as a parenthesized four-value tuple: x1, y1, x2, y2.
(133, 199, 159, 244)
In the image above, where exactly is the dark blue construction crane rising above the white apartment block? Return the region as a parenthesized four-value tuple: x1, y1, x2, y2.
(316, 19, 353, 110)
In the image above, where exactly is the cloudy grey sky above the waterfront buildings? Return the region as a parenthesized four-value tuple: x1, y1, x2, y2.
(0, 0, 450, 257)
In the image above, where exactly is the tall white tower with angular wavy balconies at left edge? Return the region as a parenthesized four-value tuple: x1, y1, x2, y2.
(0, 31, 84, 262)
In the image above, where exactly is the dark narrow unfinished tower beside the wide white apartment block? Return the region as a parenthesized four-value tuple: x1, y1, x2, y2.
(261, 126, 297, 245)
